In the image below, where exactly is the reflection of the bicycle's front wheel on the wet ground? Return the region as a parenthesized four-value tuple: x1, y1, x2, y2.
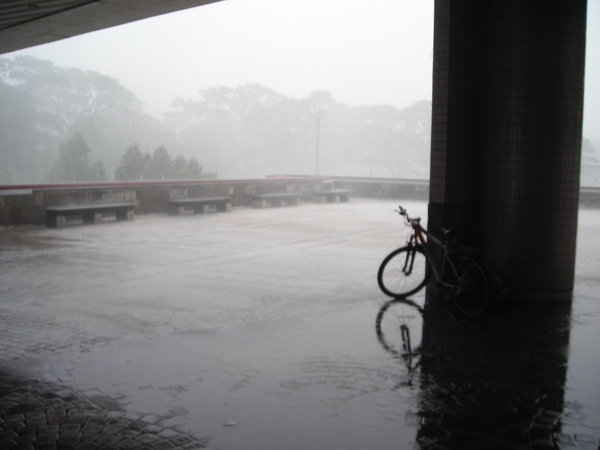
(375, 299, 423, 370)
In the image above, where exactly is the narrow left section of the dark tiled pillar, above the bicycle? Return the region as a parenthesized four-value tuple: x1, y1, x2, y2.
(429, 0, 480, 244)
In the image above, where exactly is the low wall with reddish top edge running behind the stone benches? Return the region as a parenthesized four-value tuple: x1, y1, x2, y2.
(0, 177, 600, 227)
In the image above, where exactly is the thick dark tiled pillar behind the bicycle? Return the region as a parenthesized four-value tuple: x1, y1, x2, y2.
(428, 0, 586, 300)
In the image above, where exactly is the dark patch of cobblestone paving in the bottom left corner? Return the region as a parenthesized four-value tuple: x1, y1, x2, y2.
(0, 372, 208, 450)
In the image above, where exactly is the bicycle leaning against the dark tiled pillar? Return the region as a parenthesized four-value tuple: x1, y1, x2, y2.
(377, 206, 488, 317)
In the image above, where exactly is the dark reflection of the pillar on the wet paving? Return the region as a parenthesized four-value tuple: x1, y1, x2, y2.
(417, 302, 570, 448)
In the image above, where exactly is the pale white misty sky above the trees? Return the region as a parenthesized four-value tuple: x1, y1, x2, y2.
(7, 0, 600, 141)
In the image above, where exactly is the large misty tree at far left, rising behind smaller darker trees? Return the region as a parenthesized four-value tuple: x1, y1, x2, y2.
(0, 56, 177, 181)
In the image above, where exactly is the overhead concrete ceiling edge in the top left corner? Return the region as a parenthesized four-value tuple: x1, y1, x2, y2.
(0, 0, 221, 54)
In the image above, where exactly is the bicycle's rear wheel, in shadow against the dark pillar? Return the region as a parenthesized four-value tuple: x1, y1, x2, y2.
(452, 256, 489, 317)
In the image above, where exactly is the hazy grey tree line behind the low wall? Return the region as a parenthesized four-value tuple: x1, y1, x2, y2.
(0, 56, 597, 184)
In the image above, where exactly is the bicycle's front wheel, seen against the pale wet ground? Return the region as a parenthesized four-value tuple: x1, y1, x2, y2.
(377, 245, 429, 298)
